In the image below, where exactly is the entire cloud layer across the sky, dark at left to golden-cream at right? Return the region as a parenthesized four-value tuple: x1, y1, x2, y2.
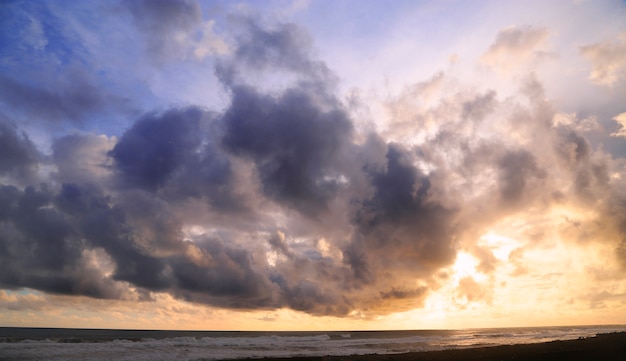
(0, 1, 626, 316)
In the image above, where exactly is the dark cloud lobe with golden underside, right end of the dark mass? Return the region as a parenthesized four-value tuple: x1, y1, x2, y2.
(334, 144, 456, 307)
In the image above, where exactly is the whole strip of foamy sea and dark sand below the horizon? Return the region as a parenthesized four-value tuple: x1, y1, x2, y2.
(0, 325, 626, 361)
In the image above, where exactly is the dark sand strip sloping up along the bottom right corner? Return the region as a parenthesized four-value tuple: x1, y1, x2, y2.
(234, 332, 626, 361)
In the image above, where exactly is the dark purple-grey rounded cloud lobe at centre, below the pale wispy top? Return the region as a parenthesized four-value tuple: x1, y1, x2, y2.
(223, 86, 352, 214)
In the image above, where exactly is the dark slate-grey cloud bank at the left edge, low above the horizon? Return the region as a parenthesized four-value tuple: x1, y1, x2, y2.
(0, 186, 124, 298)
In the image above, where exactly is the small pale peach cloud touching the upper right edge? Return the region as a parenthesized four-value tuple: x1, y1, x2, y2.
(580, 33, 626, 86)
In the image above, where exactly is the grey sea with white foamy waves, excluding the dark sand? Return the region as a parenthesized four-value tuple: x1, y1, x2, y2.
(0, 325, 626, 361)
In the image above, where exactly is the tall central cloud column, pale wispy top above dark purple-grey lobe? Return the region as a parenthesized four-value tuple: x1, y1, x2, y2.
(216, 18, 353, 215)
